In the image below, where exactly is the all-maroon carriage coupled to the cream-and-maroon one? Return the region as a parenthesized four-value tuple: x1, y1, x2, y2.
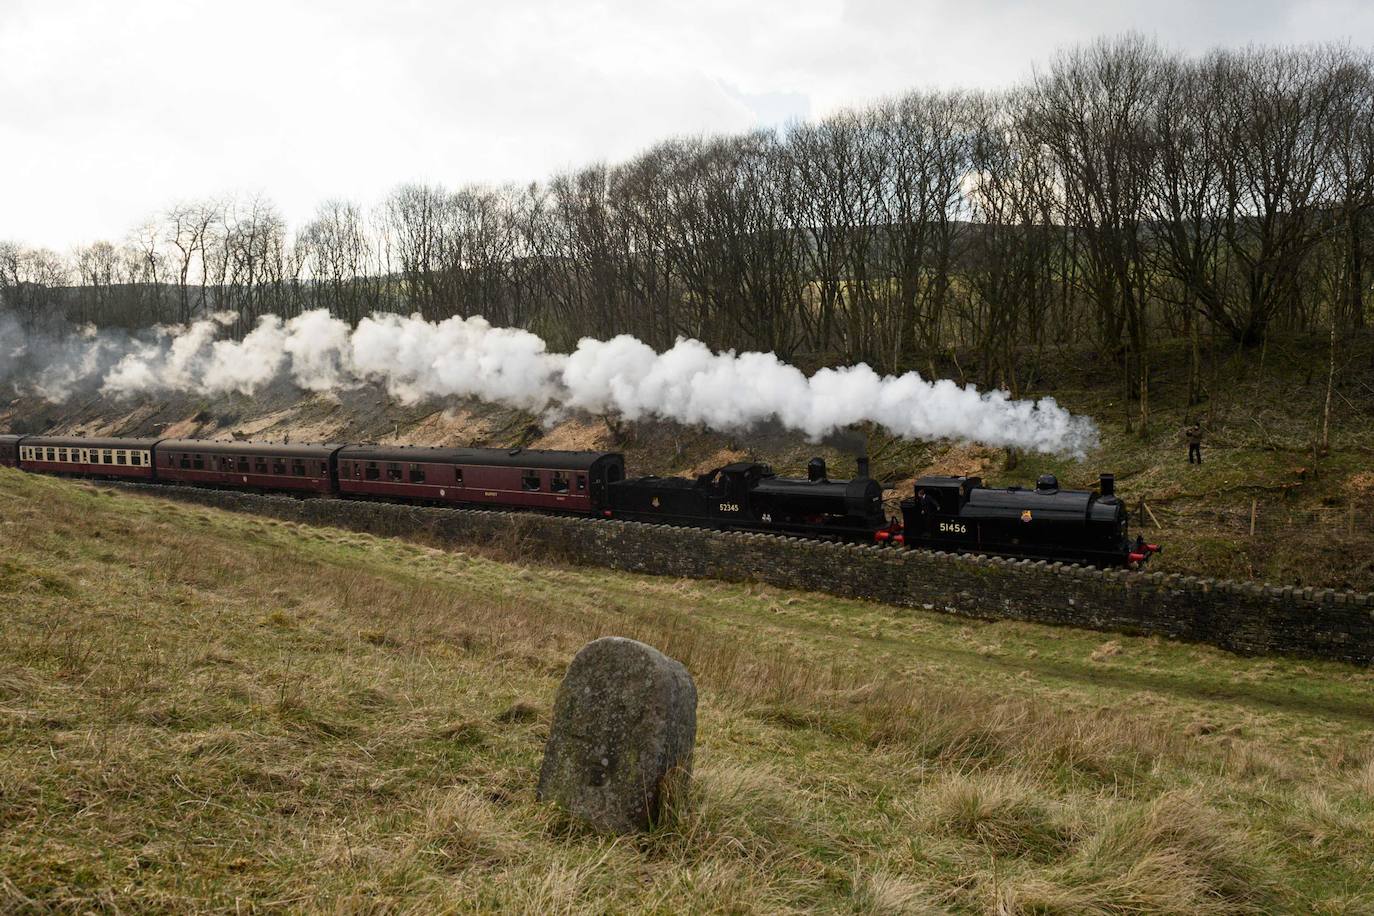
(157, 439, 341, 493)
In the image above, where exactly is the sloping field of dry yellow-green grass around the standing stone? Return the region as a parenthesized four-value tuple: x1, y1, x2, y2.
(0, 470, 1374, 915)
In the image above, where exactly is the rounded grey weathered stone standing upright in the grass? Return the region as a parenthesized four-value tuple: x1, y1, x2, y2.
(539, 636, 697, 834)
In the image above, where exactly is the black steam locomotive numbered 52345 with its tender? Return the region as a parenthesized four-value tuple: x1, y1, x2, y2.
(606, 459, 885, 540)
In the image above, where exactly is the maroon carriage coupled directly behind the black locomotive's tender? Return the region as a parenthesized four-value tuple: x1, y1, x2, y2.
(338, 445, 625, 514)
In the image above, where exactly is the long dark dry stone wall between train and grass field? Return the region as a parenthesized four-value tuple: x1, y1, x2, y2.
(120, 483, 1374, 665)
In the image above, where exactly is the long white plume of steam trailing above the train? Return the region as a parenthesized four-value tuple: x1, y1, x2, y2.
(0, 309, 1098, 457)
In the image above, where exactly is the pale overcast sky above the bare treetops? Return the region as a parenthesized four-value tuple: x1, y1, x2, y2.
(0, 0, 1374, 250)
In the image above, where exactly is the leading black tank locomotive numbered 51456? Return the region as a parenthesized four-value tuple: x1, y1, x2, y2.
(901, 474, 1157, 566)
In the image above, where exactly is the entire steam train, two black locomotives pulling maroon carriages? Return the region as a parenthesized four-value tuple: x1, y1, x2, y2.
(0, 435, 1160, 566)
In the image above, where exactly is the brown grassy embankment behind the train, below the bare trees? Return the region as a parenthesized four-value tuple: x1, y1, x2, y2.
(0, 334, 1374, 591)
